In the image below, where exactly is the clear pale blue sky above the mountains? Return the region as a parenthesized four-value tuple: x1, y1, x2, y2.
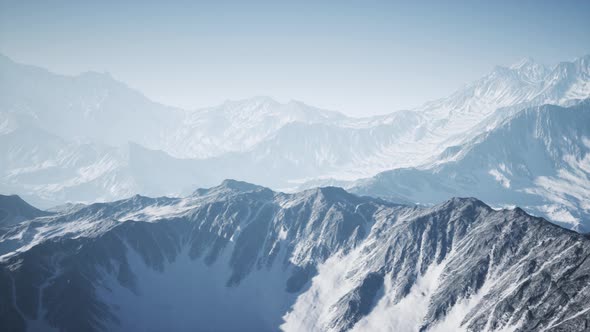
(0, 0, 590, 116)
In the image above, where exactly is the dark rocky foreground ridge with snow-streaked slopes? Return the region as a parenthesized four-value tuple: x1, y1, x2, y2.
(0, 180, 590, 331)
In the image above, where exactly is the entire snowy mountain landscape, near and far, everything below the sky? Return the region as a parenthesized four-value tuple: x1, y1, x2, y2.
(0, 50, 590, 331)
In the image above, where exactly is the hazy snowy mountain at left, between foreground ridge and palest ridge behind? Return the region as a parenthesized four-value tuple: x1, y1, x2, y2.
(0, 129, 215, 207)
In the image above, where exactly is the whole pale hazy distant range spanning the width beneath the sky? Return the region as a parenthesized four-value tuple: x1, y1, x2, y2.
(0, 56, 590, 207)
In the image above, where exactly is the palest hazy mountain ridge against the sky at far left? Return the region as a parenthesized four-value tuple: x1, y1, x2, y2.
(0, 56, 182, 150)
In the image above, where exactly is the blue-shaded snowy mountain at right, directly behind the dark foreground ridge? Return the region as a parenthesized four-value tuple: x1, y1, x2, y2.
(352, 99, 590, 232)
